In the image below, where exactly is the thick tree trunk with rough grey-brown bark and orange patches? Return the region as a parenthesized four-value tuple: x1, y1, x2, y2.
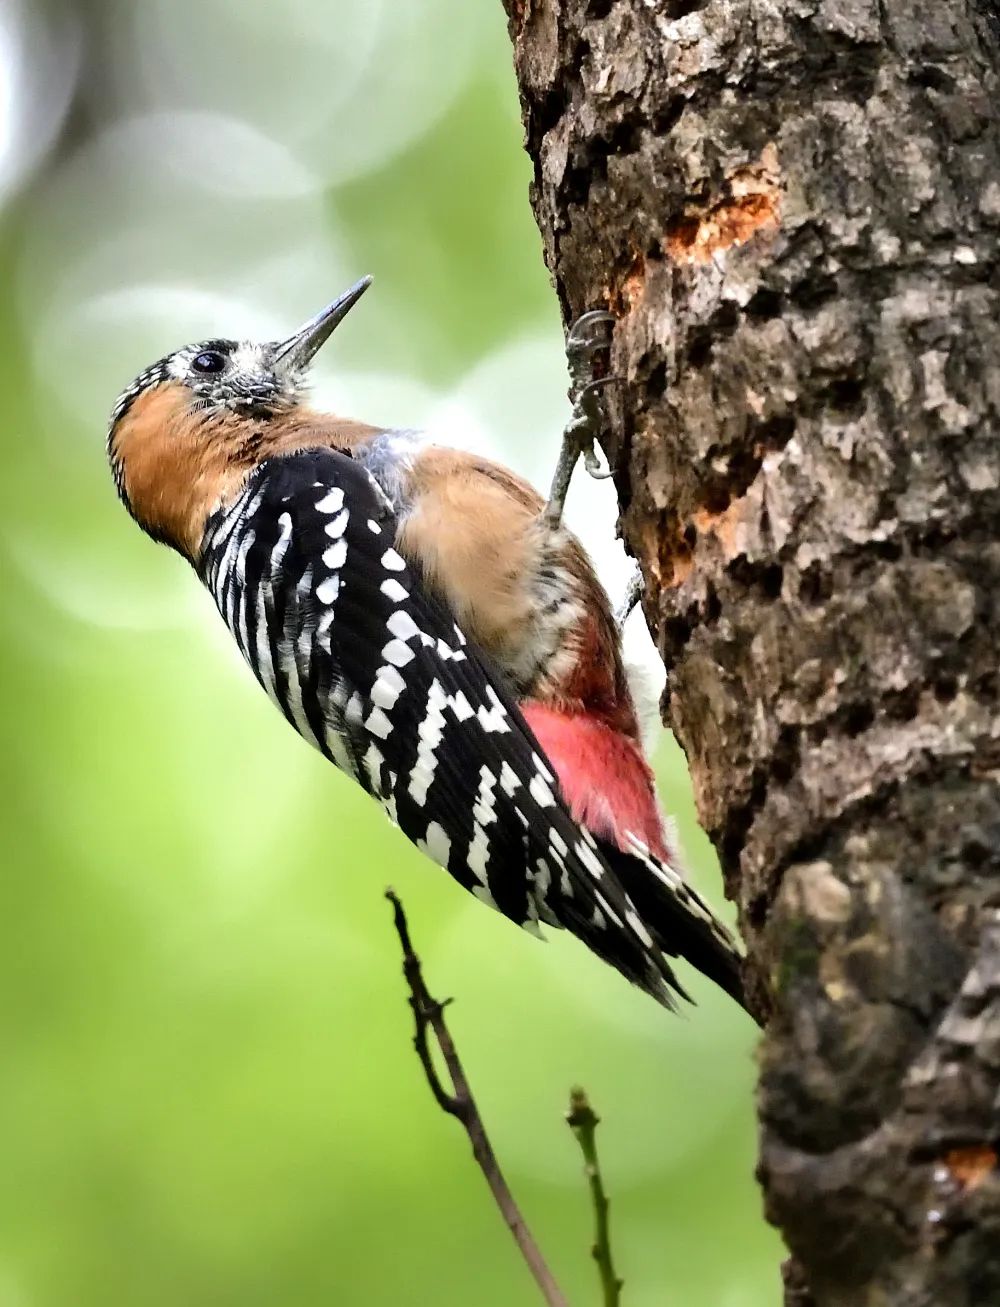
(506, 0, 1000, 1307)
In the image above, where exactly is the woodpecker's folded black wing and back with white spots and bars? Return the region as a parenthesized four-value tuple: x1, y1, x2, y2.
(199, 450, 726, 1006)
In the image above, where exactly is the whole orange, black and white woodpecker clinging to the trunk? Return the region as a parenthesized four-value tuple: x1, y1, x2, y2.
(107, 277, 744, 1008)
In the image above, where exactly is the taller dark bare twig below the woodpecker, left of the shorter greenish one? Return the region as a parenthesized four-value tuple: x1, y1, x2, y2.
(386, 890, 569, 1307)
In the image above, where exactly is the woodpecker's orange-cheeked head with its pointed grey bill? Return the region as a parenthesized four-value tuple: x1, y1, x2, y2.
(107, 277, 371, 557)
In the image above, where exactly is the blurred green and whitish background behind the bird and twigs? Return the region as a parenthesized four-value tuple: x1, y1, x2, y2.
(0, 0, 780, 1307)
